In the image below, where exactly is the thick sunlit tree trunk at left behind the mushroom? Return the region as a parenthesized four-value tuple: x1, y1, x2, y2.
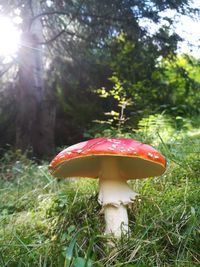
(16, 1, 55, 157)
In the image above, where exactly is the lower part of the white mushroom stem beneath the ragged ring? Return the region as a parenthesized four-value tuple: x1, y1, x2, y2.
(104, 204, 128, 238)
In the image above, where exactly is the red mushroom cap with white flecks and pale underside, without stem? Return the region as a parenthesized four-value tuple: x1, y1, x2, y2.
(49, 138, 166, 180)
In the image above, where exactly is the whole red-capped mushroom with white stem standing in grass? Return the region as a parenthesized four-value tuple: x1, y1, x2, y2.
(49, 138, 166, 237)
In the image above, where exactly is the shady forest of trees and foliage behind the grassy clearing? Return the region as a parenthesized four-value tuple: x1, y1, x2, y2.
(0, 0, 200, 157)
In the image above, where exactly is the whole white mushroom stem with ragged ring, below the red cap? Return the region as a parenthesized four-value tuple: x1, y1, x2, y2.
(98, 157, 138, 237)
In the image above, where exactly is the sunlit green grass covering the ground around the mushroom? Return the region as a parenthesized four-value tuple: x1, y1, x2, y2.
(0, 118, 200, 267)
